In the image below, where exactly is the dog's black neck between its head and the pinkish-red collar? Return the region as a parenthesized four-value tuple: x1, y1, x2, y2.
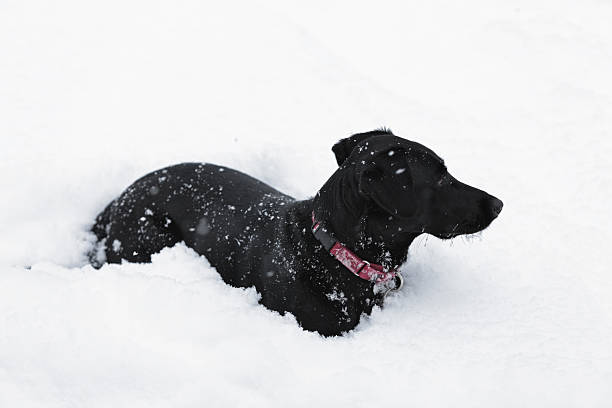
(308, 169, 419, 268)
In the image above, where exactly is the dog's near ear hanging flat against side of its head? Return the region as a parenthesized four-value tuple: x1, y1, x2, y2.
(359, 149, 417, 218)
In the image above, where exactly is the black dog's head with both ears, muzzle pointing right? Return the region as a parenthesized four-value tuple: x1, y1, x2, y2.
(332, 129, 503, 239)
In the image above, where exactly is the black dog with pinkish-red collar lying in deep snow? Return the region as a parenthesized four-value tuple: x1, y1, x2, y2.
(91, 129, 503, 336)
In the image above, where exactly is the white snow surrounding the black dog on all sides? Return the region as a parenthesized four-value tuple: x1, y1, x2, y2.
(0, 0, 612, 408)
